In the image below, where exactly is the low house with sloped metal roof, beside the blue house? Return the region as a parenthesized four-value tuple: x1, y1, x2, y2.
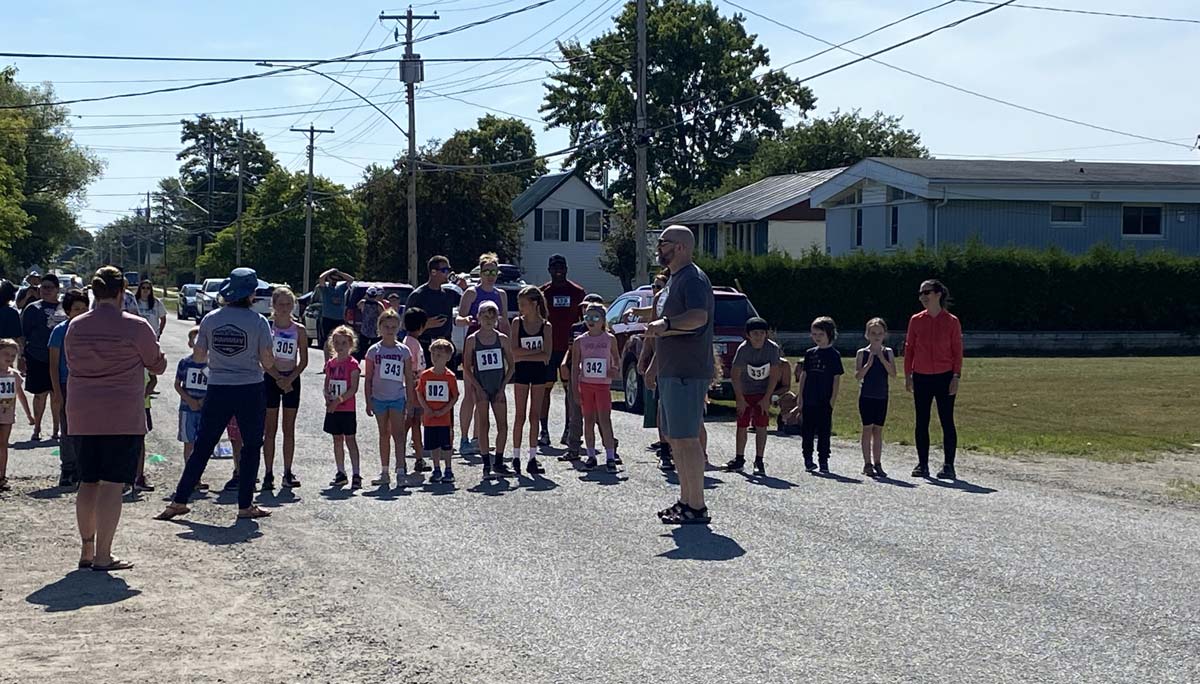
(662, 169, 842, 258)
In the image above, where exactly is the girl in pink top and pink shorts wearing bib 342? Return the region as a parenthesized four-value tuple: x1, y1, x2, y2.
(571, 304, 619, 473)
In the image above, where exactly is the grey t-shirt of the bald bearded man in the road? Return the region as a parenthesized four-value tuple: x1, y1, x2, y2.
(655, 264, 715, 379)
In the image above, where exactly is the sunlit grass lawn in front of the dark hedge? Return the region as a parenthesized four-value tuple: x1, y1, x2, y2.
(715, 356, 1200, 460)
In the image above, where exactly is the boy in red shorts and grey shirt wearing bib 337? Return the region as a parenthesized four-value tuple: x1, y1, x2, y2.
(716, 316, 781, 475)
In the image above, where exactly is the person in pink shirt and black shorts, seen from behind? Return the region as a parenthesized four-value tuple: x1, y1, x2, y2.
(62, 266, 167, 572)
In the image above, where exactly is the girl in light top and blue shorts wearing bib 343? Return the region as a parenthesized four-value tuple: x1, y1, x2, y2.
(364, 308, 415, 486)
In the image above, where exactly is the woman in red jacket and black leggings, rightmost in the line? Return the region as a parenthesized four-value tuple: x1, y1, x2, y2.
(904, 280, 962, 480)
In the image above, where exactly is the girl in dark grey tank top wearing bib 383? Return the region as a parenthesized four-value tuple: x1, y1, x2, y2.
(462, 301, 514, 479)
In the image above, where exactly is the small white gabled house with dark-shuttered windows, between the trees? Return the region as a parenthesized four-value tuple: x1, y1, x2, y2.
(512, 169, 623, 298)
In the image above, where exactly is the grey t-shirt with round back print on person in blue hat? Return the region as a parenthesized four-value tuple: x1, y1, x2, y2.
(196, 306, 271, 385)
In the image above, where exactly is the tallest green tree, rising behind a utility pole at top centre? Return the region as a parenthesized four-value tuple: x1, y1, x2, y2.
(541, 0, 816, 214)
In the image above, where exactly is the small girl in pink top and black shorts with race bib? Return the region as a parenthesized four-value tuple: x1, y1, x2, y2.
(324, 325, 362, 490)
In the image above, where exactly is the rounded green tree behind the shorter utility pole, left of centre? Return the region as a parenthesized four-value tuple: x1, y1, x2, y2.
(197, 169, 366, 288)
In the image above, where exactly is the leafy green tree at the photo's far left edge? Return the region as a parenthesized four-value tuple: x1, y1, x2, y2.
(0, 67, 103, 269)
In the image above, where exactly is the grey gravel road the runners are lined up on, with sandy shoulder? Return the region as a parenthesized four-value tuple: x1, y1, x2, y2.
(0, 320, 1200, 684)
